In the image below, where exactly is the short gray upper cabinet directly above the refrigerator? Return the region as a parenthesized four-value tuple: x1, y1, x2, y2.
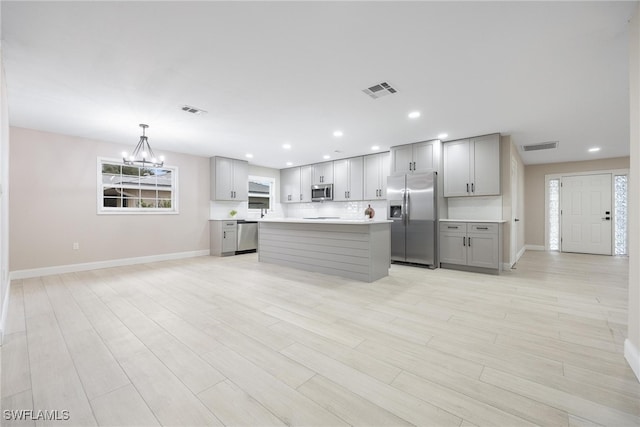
(391, 139, 440, 175)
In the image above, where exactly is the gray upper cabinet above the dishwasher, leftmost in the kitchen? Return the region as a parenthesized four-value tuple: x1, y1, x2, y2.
(209, 157, 249, 202)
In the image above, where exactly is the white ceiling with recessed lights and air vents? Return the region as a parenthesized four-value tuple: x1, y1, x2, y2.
(1, 1, 636, 168)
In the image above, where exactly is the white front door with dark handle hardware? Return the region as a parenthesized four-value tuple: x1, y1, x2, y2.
(561, 173, 613, 255)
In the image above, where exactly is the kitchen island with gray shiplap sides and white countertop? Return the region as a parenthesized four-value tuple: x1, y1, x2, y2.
(258, 218, 391, 282)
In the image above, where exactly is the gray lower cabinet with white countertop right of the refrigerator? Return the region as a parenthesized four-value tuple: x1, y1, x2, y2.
(440, 221, 502, 273)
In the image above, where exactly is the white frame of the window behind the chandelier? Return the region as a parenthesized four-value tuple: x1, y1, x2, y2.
(96, 157, 180, 215)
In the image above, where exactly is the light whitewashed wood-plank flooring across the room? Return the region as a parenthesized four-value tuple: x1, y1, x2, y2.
(2, 252, 640, 427)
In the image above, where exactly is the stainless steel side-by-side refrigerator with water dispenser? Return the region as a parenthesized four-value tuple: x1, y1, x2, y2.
(387, 172, 438, 268)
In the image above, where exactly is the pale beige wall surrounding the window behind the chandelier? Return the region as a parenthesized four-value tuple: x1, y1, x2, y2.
(10, 127, 209, 272)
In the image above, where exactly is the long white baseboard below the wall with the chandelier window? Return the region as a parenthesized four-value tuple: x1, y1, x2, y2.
(10, 249, 210, 280)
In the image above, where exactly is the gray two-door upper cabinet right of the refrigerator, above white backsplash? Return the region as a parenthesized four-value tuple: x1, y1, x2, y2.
(444, 134, 500, 197)
